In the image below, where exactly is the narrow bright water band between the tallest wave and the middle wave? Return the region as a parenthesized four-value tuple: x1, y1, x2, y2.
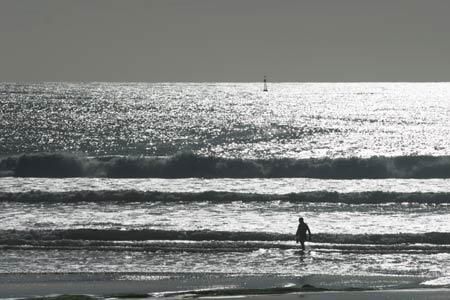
(0, 177, 450, 194)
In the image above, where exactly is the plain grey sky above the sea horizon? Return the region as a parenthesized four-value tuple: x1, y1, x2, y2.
(0, 0, 450, 82)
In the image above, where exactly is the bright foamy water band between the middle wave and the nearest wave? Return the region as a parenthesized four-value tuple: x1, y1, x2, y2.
(0, 201, 450, 234)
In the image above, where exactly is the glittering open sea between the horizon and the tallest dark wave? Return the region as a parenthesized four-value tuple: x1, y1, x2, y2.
(0, 83, 450, 158)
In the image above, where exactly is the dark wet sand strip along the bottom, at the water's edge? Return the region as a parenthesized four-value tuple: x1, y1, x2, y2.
(0, 273, 450, 300)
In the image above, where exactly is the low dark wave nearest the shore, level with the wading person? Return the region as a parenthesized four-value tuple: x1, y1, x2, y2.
(0, 228, 450, 246)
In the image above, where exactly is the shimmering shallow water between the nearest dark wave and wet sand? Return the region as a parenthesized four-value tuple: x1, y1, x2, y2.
(0, 249, 450, 278)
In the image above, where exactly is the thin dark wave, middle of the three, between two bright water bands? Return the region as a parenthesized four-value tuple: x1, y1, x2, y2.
(0, 190, 450, 204)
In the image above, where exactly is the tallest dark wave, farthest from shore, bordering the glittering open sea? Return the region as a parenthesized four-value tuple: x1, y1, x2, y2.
(0, 152, 450, 179)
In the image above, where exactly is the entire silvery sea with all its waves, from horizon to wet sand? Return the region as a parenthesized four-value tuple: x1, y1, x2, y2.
(0, 83, 450, 295)
